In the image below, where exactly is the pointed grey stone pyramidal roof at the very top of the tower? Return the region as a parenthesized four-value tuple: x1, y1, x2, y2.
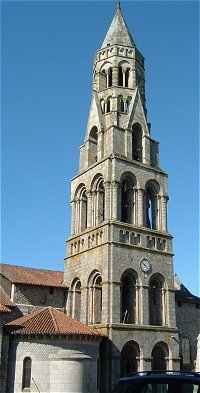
(101, 2, 135, 48)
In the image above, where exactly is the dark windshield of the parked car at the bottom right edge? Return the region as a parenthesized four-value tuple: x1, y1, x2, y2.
(113, 381, 200, 393)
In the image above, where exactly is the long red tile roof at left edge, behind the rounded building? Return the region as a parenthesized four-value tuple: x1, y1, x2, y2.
(0, 263, 65, 287)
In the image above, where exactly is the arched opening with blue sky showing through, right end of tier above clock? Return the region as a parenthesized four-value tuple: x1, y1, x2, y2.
(145, 181, 159, 229)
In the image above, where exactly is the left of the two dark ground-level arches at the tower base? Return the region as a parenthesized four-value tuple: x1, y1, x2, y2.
(120, 341, 140, 377)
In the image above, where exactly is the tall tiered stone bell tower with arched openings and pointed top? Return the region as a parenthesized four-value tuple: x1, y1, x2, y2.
(65, 3, 179, 392)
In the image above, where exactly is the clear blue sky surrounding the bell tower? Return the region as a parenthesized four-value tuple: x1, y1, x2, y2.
(2, 1, 199, 294)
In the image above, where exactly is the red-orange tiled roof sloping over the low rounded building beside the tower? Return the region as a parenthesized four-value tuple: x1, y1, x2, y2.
(6, 307, 102, 338)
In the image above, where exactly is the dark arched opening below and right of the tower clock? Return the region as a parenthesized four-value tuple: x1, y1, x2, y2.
(149, 275, 164, 326)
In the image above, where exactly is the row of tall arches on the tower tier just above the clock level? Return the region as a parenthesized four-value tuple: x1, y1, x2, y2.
(72, 172, 167, 233)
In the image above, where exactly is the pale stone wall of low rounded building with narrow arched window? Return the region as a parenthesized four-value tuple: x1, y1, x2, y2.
(7, 336, 99, 393)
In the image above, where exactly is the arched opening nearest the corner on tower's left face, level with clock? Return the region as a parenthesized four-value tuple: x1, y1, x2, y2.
(88, 272, 102, 324)
